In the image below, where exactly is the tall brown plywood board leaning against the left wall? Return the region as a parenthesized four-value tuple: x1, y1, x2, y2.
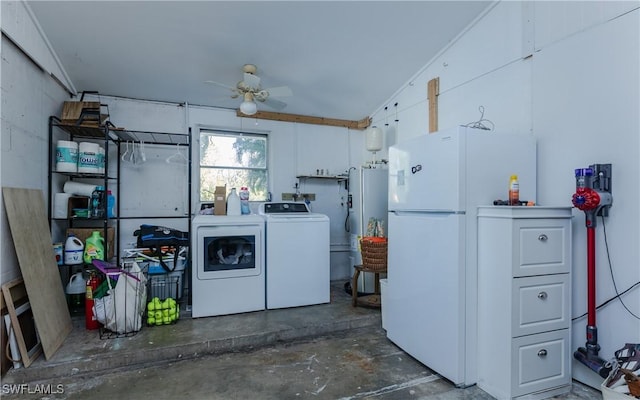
(2, 187, 72, 359)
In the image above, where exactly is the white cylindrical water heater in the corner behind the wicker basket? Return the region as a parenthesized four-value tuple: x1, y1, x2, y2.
(348, 165, 389, 293)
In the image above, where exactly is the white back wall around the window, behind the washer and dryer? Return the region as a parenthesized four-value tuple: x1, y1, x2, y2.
(62, 96, 364, 279)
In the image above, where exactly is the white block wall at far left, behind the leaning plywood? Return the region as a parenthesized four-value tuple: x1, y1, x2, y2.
(0, 35, 68, 283)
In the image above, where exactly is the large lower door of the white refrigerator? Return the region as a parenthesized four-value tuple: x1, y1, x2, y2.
(385, 212, 468, 385)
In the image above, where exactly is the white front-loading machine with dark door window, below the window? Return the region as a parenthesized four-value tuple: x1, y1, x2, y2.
(191, 214, 265, 318)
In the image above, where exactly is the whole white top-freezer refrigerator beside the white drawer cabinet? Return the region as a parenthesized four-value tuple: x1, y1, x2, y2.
(382, 127, 536, 387)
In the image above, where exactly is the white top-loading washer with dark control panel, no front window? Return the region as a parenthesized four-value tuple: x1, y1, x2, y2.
(258, 202, 330, 309)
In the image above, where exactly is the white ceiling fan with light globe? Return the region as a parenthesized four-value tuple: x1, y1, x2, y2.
(205, 64, 293, 115)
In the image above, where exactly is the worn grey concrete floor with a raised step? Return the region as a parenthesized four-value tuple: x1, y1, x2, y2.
(2, 284, 602, 400)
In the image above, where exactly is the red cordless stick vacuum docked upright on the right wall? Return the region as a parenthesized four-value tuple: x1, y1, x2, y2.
(572, 164, 613, 378)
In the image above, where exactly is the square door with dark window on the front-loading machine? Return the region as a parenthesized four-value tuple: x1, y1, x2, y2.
(193, 225, 264, 279)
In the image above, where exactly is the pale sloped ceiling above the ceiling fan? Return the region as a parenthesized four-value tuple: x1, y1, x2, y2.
(27, 1, 490, 120)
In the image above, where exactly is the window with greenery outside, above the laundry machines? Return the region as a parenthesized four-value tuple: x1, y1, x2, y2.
(200, 130, 268, 201)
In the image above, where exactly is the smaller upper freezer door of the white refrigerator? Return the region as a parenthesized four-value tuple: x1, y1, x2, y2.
(389, 127, 465, 211)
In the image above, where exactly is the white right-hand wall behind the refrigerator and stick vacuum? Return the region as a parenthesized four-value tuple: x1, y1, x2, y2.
(373, 1, 640, 385)
